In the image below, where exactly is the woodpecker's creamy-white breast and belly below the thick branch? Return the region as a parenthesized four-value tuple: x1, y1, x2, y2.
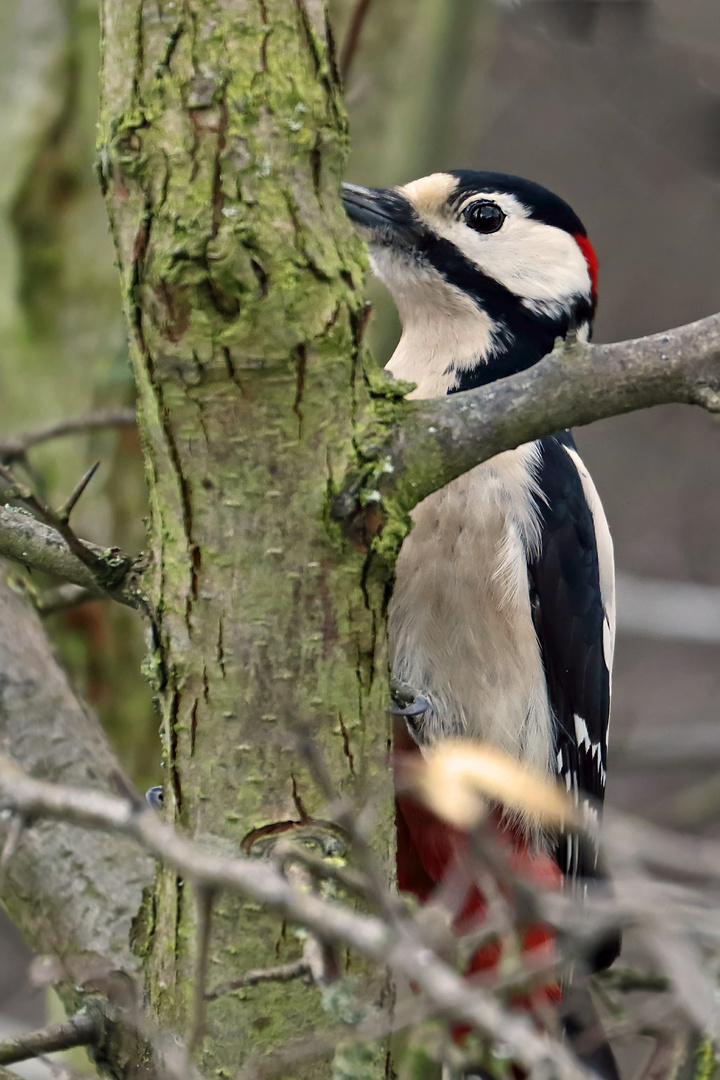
(390, 443, 555, 772)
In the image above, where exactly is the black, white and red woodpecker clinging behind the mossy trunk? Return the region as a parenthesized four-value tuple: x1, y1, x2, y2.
(342, 171, 615, 1002)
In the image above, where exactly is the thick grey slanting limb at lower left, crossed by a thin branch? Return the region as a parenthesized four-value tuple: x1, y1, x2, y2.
(0, 573, 153, 1012)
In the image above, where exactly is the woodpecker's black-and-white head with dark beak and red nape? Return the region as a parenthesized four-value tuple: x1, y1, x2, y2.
(342, 171, 597, 397)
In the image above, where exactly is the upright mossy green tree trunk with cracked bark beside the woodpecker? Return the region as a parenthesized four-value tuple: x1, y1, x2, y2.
(99, 0, 392, 1078)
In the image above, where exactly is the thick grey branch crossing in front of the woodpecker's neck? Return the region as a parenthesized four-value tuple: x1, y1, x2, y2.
(332, 314, 720, 538)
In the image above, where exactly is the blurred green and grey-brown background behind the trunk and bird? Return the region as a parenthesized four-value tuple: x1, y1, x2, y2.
(0, 0, 720, 1071)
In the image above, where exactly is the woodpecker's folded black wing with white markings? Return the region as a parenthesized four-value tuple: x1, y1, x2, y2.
(528, 432, 615, 878)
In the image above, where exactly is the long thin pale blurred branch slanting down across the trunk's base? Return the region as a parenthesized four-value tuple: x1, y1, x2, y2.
(0, 755, 588, 1080)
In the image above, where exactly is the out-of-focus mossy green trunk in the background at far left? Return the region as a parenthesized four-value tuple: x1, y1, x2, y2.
(0, 0, 157, 790)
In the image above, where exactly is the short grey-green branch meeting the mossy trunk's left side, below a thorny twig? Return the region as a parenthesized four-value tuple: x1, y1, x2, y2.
(0, 507, 148, 611)
